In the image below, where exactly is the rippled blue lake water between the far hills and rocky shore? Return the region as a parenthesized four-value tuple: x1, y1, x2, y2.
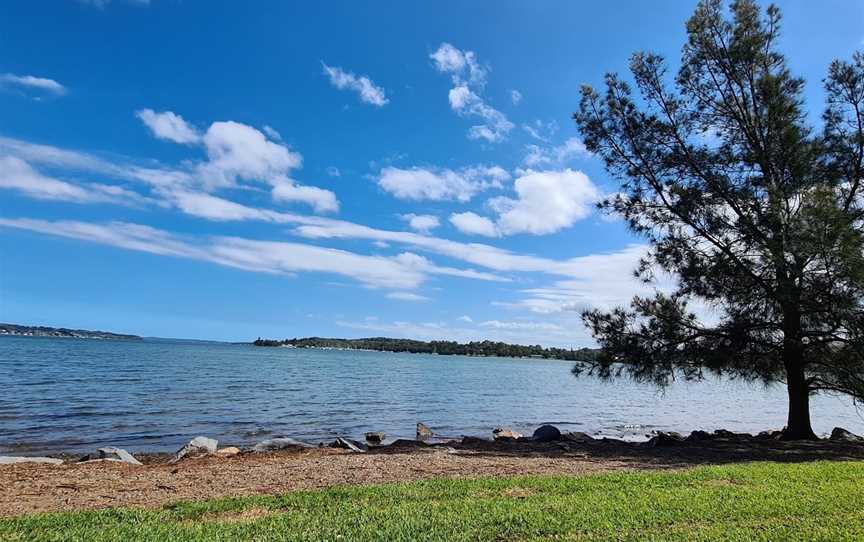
(0, 337, 864, 455)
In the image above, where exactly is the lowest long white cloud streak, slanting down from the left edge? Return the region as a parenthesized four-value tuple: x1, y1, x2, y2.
(0, 218, 502, 291)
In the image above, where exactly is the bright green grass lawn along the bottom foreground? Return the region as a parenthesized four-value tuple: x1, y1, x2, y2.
(0, 462, 864, 542)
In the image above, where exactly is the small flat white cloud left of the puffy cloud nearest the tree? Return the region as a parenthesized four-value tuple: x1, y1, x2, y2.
(378, 166, 510, 202)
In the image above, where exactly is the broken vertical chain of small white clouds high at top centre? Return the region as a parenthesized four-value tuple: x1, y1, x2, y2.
(429, 43, 510, 143)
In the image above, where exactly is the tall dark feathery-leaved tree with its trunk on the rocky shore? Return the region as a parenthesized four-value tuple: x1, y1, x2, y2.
(574, 0, 864, 438)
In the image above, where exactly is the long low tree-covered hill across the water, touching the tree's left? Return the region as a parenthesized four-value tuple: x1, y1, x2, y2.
(252, 337, 600, 361)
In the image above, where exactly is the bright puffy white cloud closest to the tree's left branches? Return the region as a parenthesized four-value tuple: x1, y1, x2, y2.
(489, 169, 600, 235)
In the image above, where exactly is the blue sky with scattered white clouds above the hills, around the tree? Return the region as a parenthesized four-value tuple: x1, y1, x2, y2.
(0, 0, 864, 346)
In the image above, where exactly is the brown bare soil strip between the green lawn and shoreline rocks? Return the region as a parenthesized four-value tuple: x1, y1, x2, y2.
(0, 437, 864, 520)
